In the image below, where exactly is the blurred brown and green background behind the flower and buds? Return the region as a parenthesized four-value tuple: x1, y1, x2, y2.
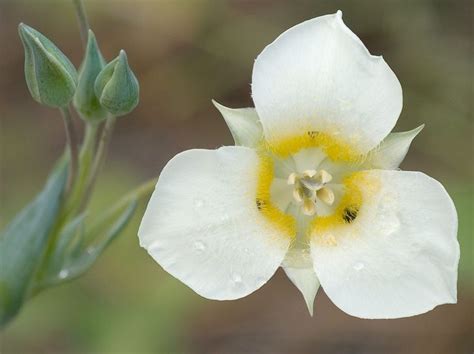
(0, 0, 474, 353)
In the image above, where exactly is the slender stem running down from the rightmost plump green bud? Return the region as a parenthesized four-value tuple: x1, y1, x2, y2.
(79, 116, 116, 210)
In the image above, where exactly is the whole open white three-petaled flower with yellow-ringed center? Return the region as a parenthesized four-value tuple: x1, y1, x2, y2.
(139, 12, 459, 318)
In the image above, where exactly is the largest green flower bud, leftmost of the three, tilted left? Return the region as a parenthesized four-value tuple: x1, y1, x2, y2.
(18, 23, 77, 107)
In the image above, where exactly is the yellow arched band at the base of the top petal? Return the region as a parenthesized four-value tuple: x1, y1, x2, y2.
(265, 130, 364, 162)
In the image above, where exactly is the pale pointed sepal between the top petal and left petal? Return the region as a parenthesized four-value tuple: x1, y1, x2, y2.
(212, 100, 263, 147)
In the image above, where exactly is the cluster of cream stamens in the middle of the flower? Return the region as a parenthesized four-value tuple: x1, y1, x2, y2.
(287, 170, 334, 216)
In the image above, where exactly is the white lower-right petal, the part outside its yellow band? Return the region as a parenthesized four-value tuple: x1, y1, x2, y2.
(311, 170, 459, 318)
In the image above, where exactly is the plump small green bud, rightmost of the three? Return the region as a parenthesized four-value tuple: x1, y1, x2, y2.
(95, 50, 139, 117)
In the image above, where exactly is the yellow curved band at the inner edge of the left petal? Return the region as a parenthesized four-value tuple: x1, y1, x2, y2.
(255, 153, 296, 238)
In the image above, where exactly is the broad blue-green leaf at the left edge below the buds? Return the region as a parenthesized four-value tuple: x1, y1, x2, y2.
(0, 160, 67, 326)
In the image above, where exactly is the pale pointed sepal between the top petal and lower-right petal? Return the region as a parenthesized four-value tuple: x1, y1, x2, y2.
(366, 124, 425, 170)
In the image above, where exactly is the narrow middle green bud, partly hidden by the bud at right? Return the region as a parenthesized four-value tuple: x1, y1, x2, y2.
(74, 30, 107, 122)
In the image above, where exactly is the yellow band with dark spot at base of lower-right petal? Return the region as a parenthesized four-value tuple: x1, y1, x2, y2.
(308, 172, 380, 245)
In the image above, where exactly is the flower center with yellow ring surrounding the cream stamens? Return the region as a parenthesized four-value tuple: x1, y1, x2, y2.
(255, 131, 364, 242)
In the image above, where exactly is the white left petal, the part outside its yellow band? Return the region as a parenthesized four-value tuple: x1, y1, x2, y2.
(138, 147, 290, 300)
